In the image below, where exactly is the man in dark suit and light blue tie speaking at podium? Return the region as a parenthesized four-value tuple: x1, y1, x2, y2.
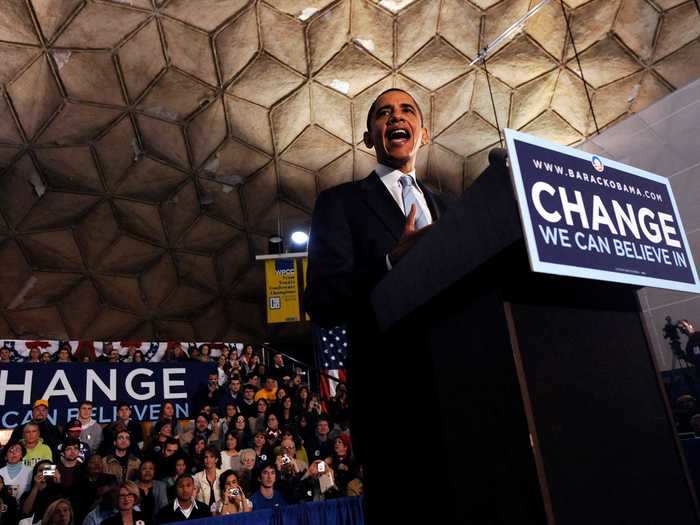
(304, 89, 446, 512)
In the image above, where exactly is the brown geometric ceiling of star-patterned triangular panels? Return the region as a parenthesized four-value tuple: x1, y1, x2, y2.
(0, 0, 700, 341)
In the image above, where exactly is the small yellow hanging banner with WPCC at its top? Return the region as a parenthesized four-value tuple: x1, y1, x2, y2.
(265, 257, 307, 323)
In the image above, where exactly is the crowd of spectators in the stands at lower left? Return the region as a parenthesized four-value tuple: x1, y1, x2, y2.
(0, 345, 363, 525)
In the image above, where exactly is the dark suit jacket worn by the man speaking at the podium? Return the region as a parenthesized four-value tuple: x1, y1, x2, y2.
(304, 172, 446, 326)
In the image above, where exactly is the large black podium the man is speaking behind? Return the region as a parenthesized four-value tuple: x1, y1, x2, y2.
(366, 165, 700, 525)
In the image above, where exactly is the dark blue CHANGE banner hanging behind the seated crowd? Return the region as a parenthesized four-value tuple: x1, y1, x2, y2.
(0, 361, 216, 428)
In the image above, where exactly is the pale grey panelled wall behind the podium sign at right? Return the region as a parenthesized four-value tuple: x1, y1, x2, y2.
(581, 80, 700, 370)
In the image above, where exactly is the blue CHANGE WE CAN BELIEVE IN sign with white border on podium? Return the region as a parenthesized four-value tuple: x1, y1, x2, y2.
(505, 129, 700, 293)
